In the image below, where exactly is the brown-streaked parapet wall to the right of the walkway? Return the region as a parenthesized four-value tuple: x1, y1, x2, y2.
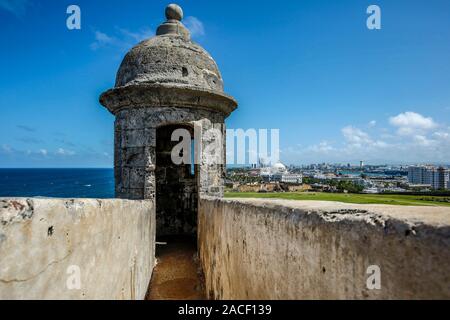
(198, 199, 450, 299)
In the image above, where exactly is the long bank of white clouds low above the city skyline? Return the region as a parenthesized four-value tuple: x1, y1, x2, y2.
(282, 112, 450, 164)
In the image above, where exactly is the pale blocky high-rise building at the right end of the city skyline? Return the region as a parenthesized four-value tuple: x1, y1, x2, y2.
(408, 166, 450, 190)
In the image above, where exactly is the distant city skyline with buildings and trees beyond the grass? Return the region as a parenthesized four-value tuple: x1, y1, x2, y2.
(229, 161, 450, 194)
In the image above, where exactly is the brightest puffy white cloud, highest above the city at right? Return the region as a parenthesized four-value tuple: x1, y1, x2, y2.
(389, 111, 437, 136)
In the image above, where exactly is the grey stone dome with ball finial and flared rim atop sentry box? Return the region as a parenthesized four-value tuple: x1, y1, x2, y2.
(99, 0, 237, 116)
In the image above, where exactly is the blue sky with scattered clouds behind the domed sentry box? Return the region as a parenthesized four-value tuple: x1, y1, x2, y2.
(0, 0, 450, 167)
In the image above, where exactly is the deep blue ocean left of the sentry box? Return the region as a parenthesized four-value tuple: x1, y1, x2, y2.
(0, 169, 114, 199)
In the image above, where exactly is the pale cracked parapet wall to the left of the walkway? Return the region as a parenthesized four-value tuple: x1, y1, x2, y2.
(0, 199, 155, 300)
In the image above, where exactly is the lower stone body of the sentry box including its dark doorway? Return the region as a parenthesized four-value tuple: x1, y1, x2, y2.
(114, 107, 225, 235)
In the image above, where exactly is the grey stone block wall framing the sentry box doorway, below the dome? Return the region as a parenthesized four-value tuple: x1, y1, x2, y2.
(114, 107, 225, 199)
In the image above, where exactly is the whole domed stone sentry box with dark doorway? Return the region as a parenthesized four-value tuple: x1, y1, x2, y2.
(100, 4, 237, 236)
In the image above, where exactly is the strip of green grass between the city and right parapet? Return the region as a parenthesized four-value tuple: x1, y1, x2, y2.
(225, 192, 450, 207)
